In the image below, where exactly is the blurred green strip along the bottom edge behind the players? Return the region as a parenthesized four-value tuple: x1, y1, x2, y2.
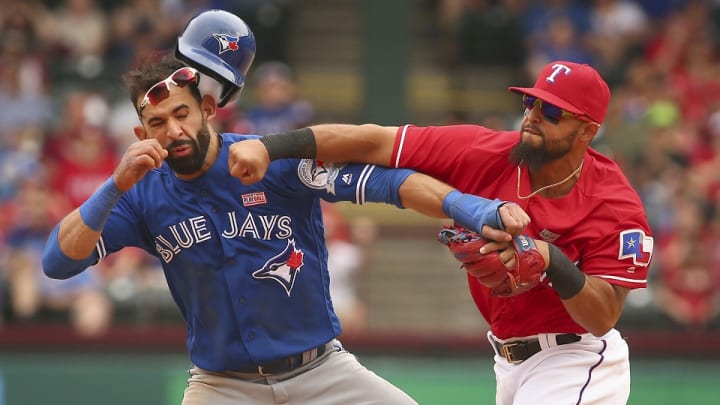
(0, 353, 720, 405)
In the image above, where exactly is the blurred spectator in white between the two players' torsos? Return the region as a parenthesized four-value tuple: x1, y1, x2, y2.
(321, 201, 377, 333)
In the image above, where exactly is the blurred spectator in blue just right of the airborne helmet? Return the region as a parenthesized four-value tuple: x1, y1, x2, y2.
(246, 62, 314, 135)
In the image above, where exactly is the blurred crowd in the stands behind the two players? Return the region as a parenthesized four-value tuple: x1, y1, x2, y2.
(0, 0, 720, 335)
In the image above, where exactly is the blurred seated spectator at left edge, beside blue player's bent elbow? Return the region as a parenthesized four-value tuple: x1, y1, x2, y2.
(1, 181, 112, 336)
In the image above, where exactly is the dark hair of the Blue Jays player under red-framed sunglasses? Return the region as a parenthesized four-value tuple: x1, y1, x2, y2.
(123, 54, 202, 109)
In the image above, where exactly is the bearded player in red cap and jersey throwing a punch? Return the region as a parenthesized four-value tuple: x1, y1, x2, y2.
(231, 61, 653, 405)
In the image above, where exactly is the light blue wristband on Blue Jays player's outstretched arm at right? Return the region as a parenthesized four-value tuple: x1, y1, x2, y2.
(443, 190, 505, 232)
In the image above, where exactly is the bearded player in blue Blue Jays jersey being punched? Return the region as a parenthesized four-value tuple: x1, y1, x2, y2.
(43, 11, 529, 405)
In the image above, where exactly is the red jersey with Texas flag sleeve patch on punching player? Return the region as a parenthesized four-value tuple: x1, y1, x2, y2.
(391, 125, 653, 339)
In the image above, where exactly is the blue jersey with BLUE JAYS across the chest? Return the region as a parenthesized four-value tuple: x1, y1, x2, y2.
(75, 134, 413, 371)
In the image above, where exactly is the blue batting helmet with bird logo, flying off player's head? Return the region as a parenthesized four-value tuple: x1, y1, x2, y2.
(175, 10, 255, 107)
